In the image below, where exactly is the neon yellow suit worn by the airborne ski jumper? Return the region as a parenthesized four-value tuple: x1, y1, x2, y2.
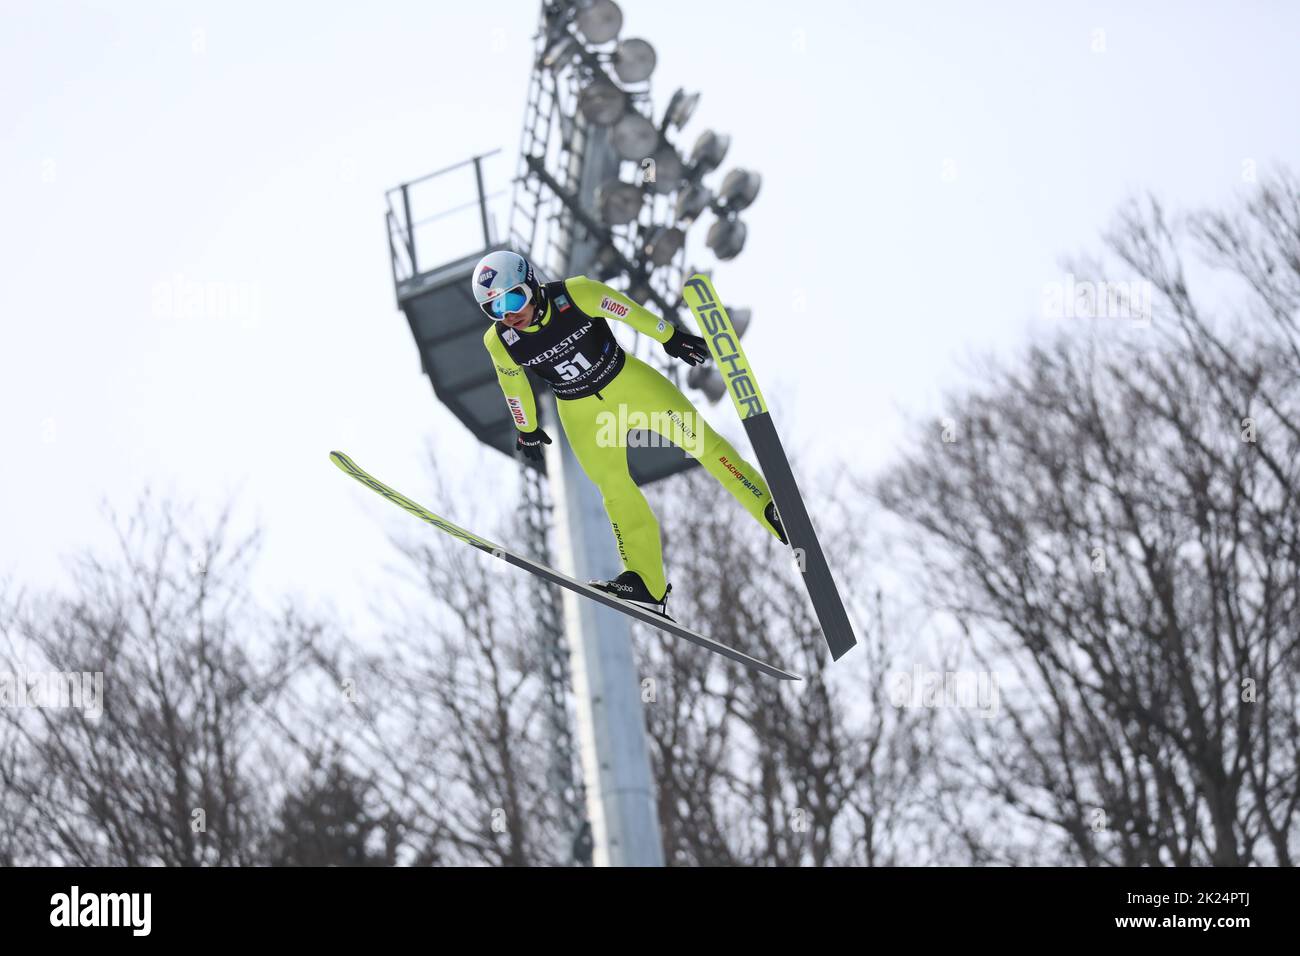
(484, 276, 780, 597)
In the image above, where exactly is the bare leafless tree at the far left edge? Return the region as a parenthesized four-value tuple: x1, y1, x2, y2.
(0, 496, 325, 865)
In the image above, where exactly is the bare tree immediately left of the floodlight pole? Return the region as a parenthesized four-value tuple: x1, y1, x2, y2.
(299, 467, 573, 866)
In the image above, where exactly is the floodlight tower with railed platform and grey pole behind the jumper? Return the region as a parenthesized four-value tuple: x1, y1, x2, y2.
(387, 0, 761, 866)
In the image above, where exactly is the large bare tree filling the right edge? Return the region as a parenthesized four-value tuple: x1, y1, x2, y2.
(876, 170, 1300, 865)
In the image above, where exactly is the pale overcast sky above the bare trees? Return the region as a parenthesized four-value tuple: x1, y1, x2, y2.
(0, 0, 1300, 624)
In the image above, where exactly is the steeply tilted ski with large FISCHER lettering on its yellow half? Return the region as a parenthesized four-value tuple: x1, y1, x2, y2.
(681, 274, 858, 661)
